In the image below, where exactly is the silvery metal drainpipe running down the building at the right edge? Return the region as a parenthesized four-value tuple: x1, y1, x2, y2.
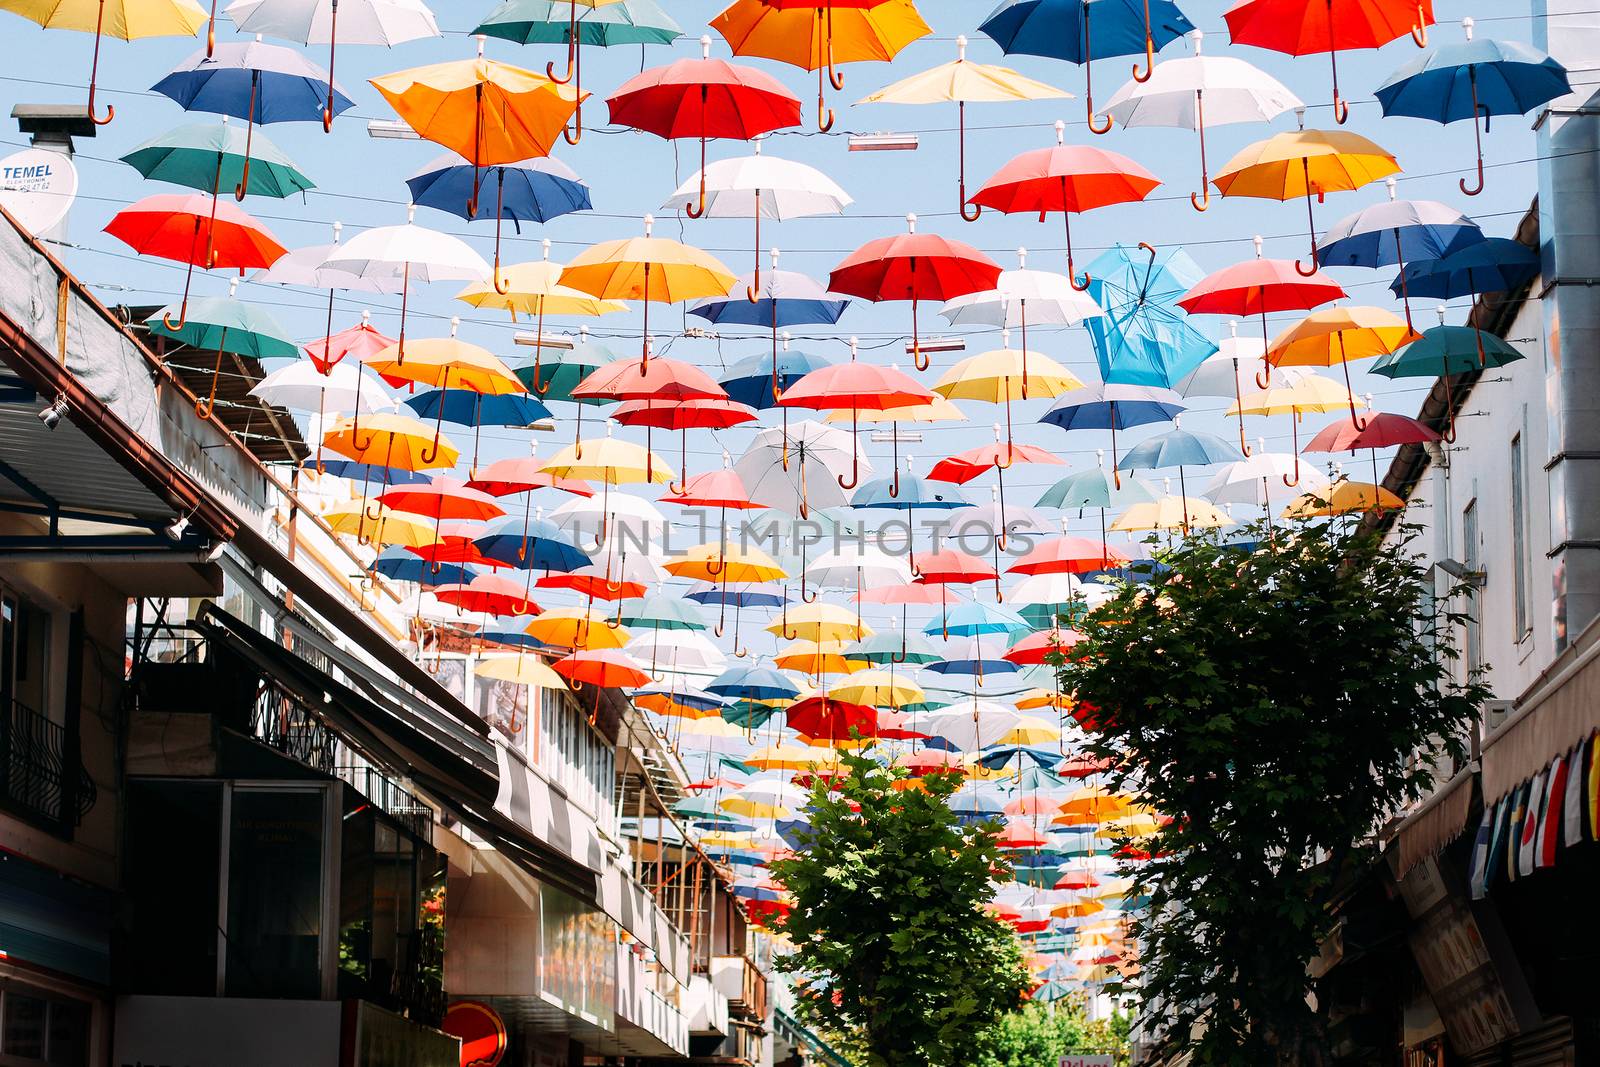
(1533, 0, 1600, 649)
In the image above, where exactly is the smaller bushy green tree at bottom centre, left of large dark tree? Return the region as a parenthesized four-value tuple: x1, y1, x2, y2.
(773, 753, 1027, 1067)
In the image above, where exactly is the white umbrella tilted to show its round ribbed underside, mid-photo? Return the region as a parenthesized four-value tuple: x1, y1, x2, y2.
(733, 419, 872, 518)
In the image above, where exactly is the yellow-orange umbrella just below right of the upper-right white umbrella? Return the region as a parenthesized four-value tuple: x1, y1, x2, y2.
(1211, 130, 1400, 278)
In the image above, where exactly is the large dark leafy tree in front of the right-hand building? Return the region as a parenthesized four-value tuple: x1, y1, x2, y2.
(1061, 522, 1486, 1067)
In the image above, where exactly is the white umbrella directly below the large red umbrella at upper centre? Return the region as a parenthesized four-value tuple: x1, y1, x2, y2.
(662, 141, 854, 301)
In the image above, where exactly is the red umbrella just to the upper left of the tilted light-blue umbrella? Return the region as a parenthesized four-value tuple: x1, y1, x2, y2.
(968, 120, 1162, 287)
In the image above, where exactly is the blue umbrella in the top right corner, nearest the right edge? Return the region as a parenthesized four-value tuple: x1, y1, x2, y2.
(1376, 30, 1573, 197)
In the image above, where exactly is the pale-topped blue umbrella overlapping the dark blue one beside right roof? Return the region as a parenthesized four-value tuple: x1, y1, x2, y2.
(1317, 178, 1483, 326)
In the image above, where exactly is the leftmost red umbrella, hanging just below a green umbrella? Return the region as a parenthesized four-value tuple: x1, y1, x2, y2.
(106, 194, 288, 330)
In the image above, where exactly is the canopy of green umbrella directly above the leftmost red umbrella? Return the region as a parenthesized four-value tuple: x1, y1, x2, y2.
(122, 118, 314, 200)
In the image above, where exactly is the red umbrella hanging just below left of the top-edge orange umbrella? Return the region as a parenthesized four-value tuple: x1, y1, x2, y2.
(606, 37, 800, 219)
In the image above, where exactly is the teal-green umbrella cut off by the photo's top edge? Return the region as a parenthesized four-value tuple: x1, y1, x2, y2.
(472, 0, 683, 144)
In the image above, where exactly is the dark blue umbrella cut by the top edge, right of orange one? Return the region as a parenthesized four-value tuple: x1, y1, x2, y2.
(978, 0, 1195, 133)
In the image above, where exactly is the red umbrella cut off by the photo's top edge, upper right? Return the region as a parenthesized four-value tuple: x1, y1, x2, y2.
(1222, 0, 1434, 126)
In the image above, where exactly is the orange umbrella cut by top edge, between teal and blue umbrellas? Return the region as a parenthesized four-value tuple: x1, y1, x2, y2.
(710, 0, 933, 133)
